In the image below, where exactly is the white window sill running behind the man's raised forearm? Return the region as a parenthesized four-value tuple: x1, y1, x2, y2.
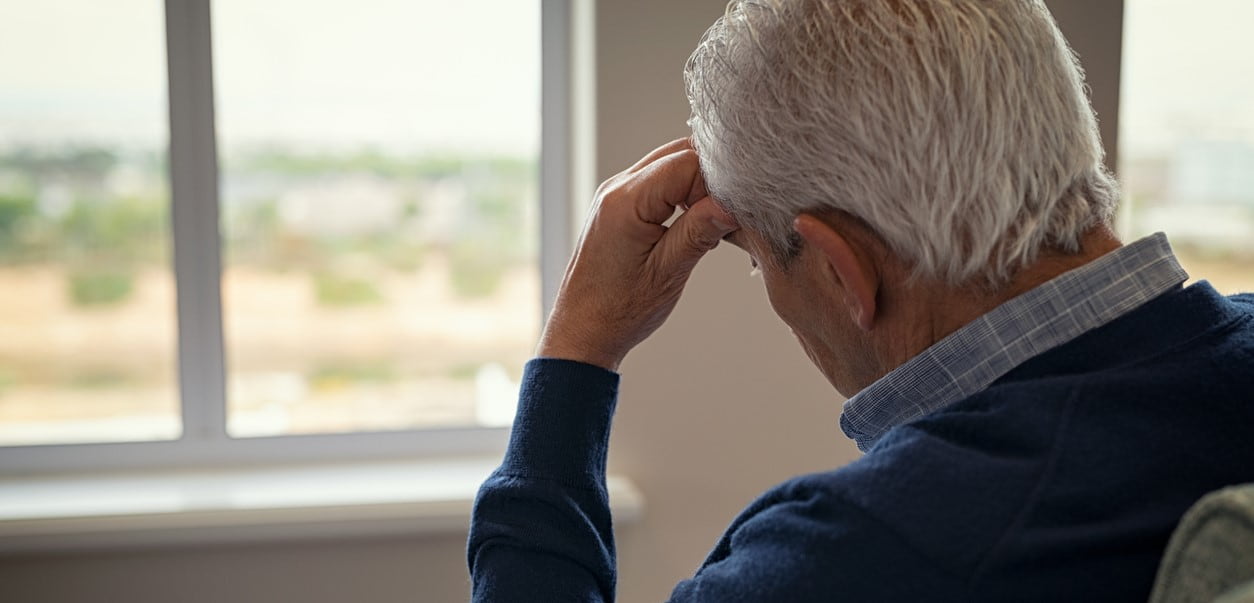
(0, 458, 643, 553)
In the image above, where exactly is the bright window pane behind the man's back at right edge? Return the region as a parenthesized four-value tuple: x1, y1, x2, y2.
(1120, 0, 1254, 293)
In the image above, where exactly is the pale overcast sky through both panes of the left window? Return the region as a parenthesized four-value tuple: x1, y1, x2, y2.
(0, 0, 539, 153)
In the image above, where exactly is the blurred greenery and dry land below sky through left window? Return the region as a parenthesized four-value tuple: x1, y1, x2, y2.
(0, 148, 540, 443)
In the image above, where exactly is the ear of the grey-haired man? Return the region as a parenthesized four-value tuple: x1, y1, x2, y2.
(793, 213, 880, 331)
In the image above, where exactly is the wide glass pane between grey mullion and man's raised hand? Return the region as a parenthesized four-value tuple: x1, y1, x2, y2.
(213, 0, 540, 436)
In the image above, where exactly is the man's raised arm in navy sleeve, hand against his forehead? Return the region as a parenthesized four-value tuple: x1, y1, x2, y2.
(468, 139, 736, 602)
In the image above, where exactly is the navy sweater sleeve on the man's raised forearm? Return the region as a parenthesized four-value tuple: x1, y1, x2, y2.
(466, 359, 618, 602)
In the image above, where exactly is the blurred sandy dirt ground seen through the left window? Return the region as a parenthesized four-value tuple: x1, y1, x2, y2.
(0, 257, 540, 444)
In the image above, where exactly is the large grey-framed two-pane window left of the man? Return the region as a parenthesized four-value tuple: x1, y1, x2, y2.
(0, 0, 569, 470)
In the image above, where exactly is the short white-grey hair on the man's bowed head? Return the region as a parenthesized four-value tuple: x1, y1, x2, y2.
(683, 0, 1119, 287)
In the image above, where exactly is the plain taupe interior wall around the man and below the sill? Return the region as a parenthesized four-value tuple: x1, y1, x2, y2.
(0, 0, 1122, 603)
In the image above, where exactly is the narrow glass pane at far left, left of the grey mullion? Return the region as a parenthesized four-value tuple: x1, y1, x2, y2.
(0, 0, 179, 441)
